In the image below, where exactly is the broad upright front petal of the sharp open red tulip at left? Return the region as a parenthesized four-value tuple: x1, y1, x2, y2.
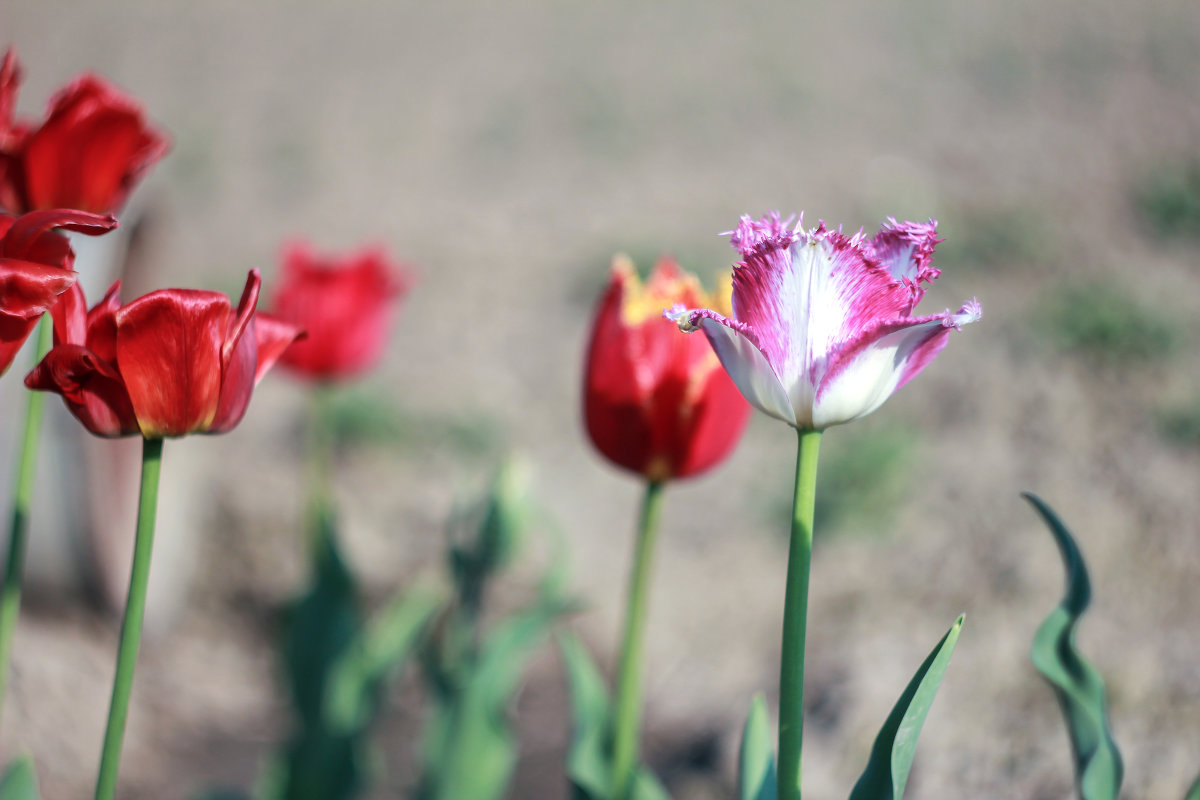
(116, 289, 230, 438)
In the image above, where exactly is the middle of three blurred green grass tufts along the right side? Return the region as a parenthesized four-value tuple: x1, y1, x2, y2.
(1033, 282, 1183, 366)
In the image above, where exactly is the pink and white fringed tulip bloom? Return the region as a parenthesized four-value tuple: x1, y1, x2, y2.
(665, 212, 982, 431)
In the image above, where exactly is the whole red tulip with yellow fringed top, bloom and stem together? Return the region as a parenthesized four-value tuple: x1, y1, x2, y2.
(583, 258, 750, 799)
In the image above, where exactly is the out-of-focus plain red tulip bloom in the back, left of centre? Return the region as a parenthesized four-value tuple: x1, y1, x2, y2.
(272, 241, 410, 380)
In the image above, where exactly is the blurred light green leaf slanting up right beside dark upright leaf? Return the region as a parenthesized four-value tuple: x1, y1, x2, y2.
(325, 582, 444, 733)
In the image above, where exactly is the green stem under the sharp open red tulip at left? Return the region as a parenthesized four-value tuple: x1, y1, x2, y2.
(96, 439, 162, 800)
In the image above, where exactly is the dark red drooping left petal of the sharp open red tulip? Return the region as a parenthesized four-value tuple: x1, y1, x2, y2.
(25, 344, 138, 437)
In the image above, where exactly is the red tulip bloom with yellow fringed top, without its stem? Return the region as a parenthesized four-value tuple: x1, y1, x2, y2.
(583, 259, 750, 481)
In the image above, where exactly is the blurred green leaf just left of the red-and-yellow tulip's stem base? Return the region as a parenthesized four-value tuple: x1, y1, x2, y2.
(558, 633, 612, 800)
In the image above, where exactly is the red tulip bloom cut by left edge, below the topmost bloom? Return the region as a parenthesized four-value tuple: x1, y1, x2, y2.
(0, 209, 116, 374)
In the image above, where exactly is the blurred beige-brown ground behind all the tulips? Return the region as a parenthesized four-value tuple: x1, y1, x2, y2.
(0, 0, 1200, 800)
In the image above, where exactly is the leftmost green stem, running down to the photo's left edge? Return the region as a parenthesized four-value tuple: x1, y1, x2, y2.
(0, 314, 54, 715)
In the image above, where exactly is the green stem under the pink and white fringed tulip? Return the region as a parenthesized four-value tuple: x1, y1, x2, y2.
(779, 431, 821, 800)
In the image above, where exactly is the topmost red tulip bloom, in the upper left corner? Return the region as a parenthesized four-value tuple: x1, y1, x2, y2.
(0, 50, 168, 212)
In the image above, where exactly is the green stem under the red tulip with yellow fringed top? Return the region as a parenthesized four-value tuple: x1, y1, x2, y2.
(612, 481, 662, 800)
